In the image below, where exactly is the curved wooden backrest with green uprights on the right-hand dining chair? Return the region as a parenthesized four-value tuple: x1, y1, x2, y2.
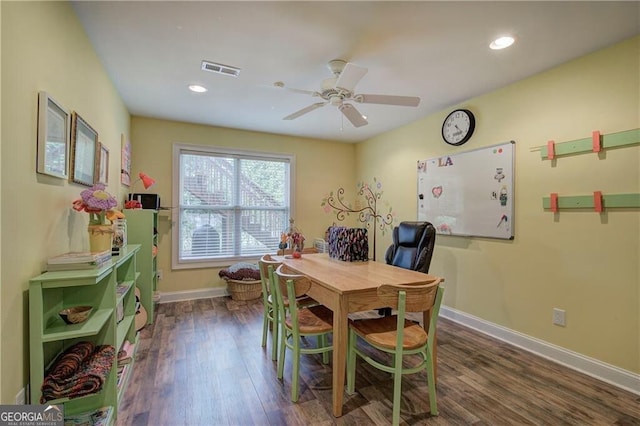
(378, 278, 444, 347)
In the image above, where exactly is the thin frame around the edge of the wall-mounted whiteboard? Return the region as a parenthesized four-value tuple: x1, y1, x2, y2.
(417, 140, 516, 240)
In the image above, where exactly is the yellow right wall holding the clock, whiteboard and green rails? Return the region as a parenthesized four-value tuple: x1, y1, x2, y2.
(356, 37, 640, 373)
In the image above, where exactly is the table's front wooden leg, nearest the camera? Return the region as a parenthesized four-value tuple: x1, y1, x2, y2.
(332, 299, 349, 417)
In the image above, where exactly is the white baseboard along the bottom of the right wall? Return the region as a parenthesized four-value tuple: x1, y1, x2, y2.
(440, 306, 640, 395)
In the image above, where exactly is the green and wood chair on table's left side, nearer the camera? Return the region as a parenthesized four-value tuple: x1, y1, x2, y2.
(269, 265, 333, 402)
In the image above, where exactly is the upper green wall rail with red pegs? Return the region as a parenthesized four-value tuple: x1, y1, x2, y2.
(535, 129, 640, 160)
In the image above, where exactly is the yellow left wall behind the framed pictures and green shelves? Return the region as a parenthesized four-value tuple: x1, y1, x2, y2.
(0, 1, 129, 404)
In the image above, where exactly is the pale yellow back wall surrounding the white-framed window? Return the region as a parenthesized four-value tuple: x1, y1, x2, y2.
(131, 117, 355, 293)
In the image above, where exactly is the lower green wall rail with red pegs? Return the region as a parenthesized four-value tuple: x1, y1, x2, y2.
(542, 191, 640, 212)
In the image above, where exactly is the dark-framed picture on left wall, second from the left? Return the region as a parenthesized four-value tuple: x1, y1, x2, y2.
(71, 112, 98, 186)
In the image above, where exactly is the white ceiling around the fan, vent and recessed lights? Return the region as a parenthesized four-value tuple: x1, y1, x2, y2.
(73, 1, 640, 142)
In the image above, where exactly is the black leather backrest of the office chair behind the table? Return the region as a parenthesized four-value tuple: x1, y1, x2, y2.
(385, 222, 436, 273)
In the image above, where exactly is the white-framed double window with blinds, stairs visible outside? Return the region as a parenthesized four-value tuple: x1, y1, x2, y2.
(172, 144, 294, 269)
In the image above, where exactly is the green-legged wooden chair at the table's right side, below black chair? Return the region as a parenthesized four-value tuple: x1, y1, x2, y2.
(347, 278, 444, 426)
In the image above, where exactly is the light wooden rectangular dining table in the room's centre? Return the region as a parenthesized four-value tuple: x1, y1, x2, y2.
(276, 253, 436, 417)
